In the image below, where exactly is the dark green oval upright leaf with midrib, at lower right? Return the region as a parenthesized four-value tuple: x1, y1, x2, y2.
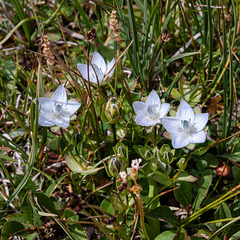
(174, 181, 192, 207)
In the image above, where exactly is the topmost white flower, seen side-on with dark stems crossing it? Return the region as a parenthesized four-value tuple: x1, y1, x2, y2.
(77, 51, 115, 84)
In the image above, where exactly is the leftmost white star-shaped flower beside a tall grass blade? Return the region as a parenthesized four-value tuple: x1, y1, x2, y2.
(38, 85, 81, 128)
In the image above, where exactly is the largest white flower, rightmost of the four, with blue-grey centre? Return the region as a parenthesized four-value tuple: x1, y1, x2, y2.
(161, 100, 208, 148)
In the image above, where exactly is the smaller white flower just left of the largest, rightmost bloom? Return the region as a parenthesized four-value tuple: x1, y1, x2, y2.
(133, 90, 170, 127)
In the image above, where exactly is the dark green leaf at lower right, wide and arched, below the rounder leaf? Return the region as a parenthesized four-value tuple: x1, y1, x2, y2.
(145, 206, 179, 227)
